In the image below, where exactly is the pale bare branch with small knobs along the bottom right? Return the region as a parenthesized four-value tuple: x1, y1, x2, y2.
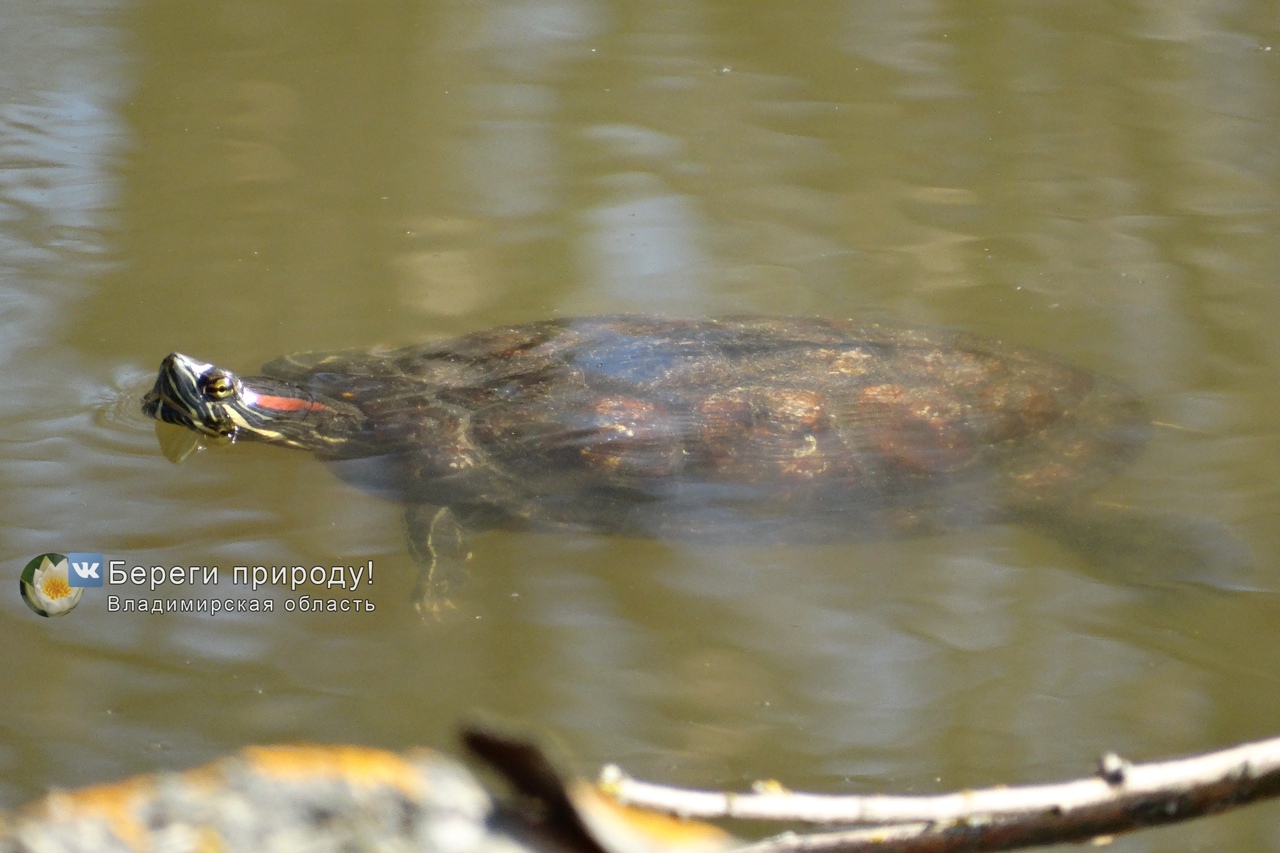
(600, 738, 1280, 853)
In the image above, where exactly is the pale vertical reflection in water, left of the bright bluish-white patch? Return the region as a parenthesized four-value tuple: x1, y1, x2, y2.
(396, 0, 604, 321)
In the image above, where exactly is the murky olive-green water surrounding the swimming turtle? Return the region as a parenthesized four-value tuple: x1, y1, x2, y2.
(0, 0, 1280, 850)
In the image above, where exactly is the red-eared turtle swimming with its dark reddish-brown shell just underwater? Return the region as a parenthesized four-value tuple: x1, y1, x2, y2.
(135, 316, 1223, 612)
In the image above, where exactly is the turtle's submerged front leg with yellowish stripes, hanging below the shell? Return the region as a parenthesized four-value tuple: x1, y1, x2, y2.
(404, 503, 471, 620)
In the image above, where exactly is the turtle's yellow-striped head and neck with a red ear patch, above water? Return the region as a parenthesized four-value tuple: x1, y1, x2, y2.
(142, 352, 364, 456)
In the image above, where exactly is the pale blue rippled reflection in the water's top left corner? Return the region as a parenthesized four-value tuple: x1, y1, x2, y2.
(0, 3, 129, 356)
